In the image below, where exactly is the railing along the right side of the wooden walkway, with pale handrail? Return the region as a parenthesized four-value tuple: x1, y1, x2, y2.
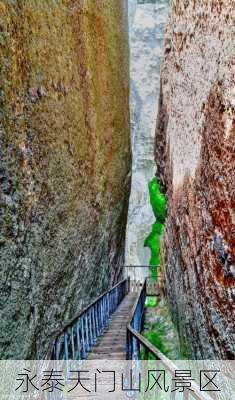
(126, 279, 212, 400)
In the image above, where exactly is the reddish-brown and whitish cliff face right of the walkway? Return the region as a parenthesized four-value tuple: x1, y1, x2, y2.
(156, 0, 235, 359)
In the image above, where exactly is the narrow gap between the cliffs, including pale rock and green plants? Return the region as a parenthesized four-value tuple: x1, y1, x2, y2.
(125, 0, 184, 359)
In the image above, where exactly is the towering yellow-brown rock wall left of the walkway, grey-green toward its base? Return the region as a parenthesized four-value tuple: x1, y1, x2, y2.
(0, 0, 130, 359)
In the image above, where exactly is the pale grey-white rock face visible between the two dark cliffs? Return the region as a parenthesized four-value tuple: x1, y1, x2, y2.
(125, 0, 169, 277)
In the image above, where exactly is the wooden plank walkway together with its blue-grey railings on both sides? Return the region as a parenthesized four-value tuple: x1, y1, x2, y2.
(45, 279, 211, 400)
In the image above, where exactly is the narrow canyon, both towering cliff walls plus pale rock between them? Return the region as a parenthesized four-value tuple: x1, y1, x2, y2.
(0, 0, 235, 359)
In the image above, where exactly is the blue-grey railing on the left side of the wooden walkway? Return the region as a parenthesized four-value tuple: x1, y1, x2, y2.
(47, 279, 130, 360)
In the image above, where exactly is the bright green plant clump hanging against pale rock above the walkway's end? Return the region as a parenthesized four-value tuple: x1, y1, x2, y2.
(144, 177, 167, 280)
